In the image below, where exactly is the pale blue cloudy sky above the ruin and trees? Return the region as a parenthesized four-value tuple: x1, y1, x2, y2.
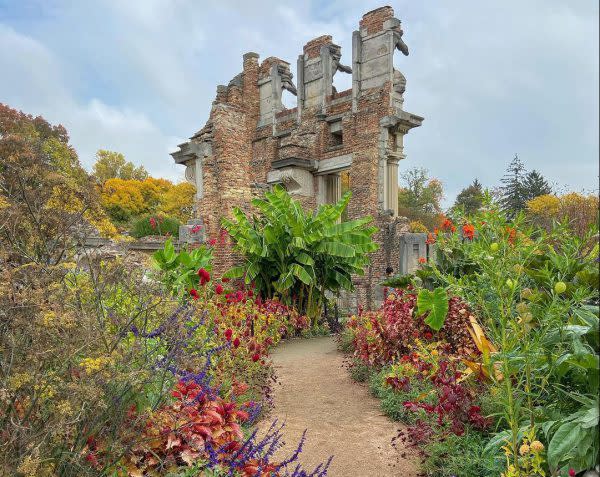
(0, 0, 599, 204)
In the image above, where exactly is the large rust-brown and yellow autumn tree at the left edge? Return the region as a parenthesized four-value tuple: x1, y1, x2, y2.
(0, 104, 116, 264)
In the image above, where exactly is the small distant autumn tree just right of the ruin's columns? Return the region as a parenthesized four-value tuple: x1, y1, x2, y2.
(398, 167, 444, 230)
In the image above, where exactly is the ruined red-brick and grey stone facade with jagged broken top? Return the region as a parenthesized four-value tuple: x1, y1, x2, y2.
(172, 6, 423, 308)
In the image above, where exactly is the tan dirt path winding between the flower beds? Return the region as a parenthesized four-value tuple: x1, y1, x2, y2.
(261, 337, 418, 477)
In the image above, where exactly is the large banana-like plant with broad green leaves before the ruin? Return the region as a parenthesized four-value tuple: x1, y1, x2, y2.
(223, 186, 378, 319)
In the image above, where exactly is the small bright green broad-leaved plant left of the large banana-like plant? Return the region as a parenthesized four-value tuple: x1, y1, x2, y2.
(152, 239, 213, 297)
